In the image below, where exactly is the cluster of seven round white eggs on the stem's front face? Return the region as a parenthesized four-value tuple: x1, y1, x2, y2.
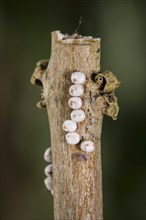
(62, 72, 94, 152)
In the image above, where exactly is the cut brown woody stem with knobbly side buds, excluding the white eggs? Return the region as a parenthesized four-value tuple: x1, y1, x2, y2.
(31, 31, 119, 220)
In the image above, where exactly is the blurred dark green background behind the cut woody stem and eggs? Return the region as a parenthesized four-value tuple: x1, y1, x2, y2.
(0, 0, 146, 220)
